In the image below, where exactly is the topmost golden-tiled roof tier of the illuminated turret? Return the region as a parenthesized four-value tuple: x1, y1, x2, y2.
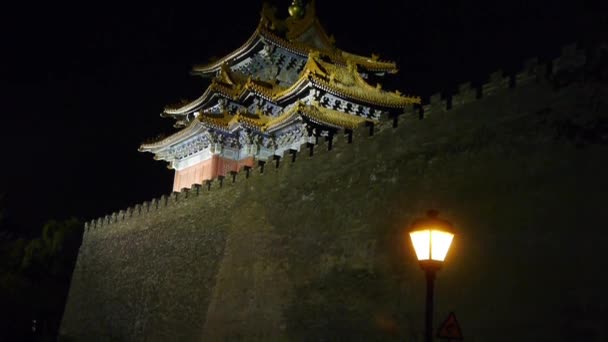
(192, 1, 397, 75)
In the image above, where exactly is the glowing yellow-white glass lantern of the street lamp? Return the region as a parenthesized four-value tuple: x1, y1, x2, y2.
(410, 228, 454, 261)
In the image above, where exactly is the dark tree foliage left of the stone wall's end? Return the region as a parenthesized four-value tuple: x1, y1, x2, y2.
(0, 218, 82, 340)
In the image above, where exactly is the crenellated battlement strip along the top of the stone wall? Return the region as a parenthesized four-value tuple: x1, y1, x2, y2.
(85, 44, 589, 238)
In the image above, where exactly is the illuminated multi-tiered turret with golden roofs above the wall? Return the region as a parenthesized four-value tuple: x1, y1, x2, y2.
(140, 1, 420, 191)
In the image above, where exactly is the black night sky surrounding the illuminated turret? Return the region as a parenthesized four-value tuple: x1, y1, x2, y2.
(0, 0, 606, 232)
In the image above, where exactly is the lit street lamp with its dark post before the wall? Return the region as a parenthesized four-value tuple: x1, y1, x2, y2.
(409, 210, 454, 342)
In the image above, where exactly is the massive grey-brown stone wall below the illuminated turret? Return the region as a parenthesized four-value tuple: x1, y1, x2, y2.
(61, 44, 608, 341)
